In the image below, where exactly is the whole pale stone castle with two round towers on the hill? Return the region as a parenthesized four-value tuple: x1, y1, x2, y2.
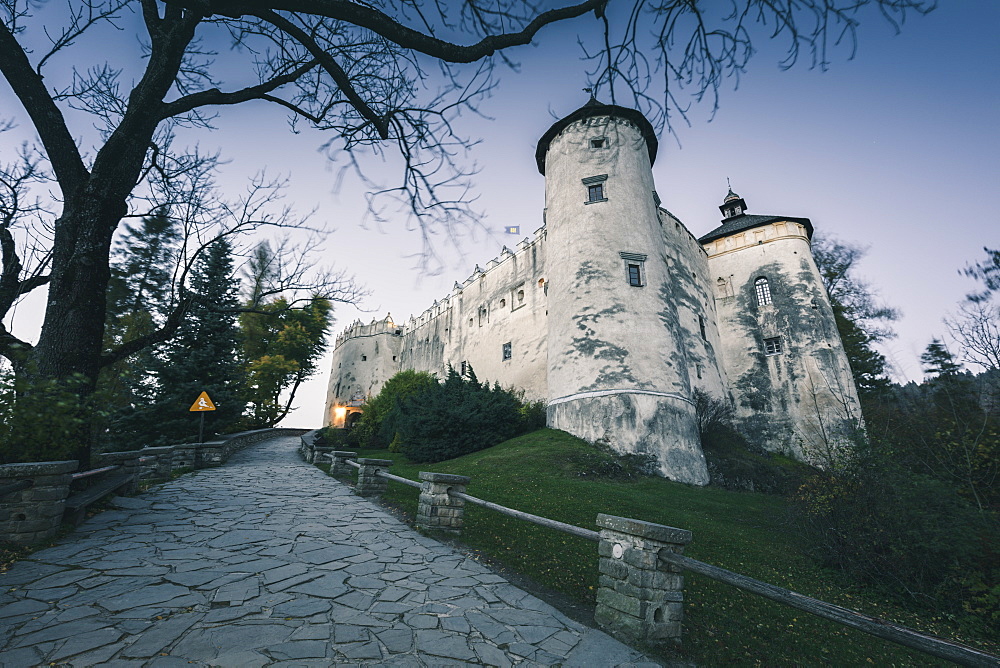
(325, 98, 860, 485)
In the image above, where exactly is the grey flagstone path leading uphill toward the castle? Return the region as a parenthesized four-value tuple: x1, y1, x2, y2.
(0, 437, 649, 668)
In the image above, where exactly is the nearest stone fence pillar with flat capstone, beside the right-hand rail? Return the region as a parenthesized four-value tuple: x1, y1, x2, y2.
(594, 514, 691, 644)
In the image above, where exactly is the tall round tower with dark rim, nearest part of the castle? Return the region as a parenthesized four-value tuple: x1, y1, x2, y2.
(535, 97, 708, 485)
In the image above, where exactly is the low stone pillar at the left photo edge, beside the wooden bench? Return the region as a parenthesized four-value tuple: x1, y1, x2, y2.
(0, 461, 80, 545)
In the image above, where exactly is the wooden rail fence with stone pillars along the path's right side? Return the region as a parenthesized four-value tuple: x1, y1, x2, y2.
(324, 452, 1000, 668)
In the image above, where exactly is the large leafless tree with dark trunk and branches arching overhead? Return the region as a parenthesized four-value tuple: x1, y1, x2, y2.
(0, 0, 932, 460)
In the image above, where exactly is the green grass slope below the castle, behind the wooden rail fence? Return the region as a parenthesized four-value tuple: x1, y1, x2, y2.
(332, 429, 1000, 666)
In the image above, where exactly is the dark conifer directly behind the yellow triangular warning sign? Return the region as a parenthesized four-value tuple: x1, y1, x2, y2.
(143, 238, 245, 443)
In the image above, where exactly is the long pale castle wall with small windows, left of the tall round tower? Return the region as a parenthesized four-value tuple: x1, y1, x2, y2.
(325, 230, 548, 426)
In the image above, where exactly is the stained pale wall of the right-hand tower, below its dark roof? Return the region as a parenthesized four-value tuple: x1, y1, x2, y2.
(706, 221, 861, 463)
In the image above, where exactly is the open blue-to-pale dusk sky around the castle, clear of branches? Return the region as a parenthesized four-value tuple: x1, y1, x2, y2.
(0, 0, 1000, 427)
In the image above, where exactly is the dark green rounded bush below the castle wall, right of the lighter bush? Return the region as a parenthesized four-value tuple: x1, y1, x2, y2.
(395, 366, 522, 463)
